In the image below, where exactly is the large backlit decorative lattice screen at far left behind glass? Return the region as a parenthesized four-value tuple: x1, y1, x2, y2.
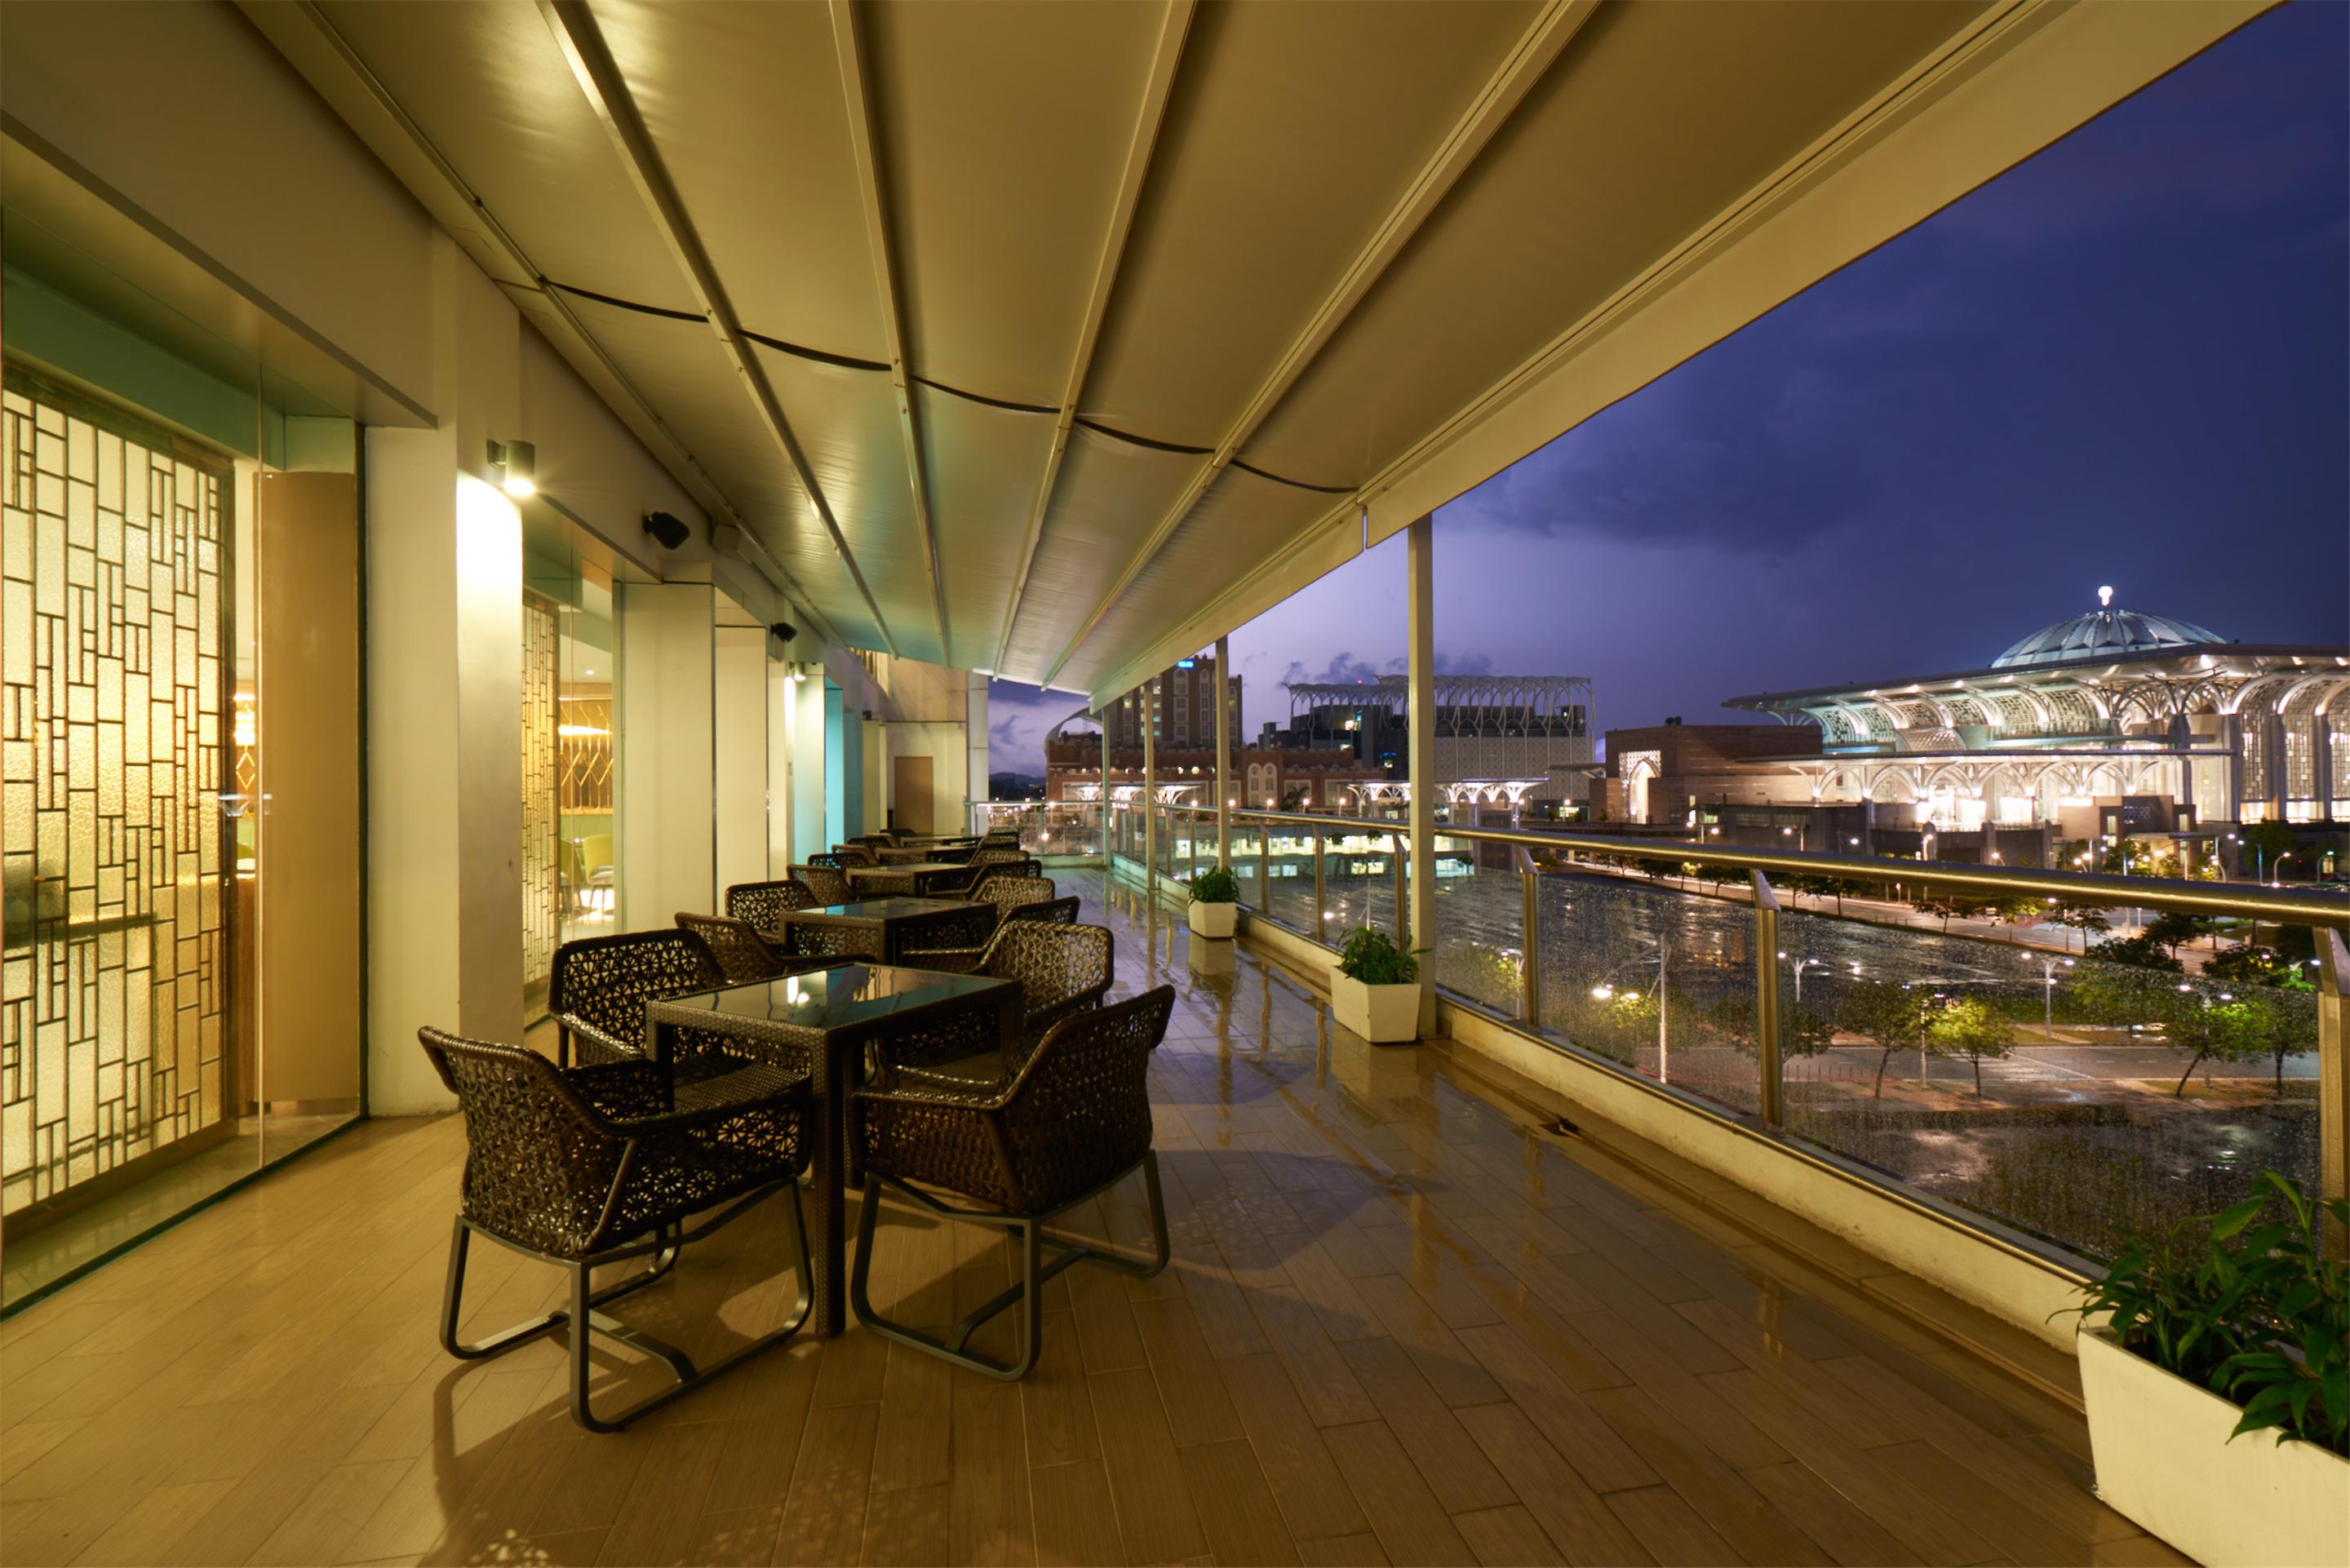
(0, 369, 235, 1211)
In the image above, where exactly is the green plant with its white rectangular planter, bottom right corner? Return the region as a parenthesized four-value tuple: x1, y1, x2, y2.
(2080, 1171, 2350, 1568)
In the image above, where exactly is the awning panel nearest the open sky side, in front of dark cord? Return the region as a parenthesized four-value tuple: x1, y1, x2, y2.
(1250, 0, 1984, 482)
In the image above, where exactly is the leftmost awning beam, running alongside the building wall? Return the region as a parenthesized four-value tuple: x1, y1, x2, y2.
(240, 0, 844, 642)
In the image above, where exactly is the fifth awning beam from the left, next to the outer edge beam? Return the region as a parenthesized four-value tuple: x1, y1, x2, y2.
(1044, 0, 1598, 680)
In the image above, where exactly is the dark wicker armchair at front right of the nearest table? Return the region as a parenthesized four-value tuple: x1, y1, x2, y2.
(849, 985, 1175, 1380)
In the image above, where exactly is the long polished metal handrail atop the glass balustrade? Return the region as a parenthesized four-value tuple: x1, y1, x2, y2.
(1159, 804, 2350, 926)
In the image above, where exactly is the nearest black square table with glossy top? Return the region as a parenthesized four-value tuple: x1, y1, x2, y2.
(644, 963, 1022, 1338)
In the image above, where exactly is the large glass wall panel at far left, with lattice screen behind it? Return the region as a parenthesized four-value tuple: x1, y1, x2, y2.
(0, 209, 360, 1304)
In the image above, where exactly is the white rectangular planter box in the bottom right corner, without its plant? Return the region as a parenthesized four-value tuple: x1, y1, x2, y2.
(2080, 1328, 2350, 1568)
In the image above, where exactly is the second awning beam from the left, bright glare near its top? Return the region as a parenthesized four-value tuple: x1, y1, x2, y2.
(539, 0, 900, 658)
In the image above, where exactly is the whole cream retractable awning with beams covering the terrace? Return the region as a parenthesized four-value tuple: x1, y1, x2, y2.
(245, 0, 2265, 698)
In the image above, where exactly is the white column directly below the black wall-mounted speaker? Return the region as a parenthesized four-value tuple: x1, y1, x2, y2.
(614, 583, 716, 931)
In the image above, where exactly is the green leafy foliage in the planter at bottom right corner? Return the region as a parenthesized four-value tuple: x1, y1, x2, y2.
(2070, 1171, 2350, 1455)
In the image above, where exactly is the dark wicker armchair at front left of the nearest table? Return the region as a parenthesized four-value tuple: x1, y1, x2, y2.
(416, 1030, 813, 1432)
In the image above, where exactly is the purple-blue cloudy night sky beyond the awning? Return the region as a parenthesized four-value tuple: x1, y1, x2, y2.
(991, 0, 2350, 773)
